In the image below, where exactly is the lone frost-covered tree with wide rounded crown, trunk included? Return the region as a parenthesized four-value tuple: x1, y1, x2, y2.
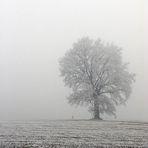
(60, 37, 134, 119)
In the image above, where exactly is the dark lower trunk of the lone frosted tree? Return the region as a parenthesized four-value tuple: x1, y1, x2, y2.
(94, 95, 102, 120)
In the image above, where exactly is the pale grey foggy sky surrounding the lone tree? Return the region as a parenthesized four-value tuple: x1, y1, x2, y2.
(0, 0, 148, 121)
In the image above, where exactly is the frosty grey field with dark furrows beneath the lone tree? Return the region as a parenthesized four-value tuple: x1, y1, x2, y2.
(0, 120, 148, 148)
